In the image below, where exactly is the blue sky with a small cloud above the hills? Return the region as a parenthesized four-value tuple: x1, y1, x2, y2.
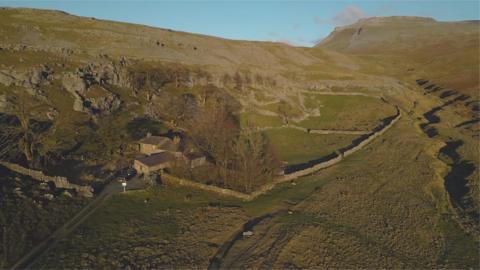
(0, 0, 480, 46)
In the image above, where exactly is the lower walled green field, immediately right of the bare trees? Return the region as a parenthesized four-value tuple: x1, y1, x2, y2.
(265, 128, 358, 164)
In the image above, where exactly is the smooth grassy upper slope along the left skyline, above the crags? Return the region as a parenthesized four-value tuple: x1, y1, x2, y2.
(0, 8, 316, 75)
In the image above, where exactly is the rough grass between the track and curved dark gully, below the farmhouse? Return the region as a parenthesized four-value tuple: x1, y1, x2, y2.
(38, 188, 246, 269)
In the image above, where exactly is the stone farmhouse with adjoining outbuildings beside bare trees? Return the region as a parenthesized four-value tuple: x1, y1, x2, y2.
(133, 135, 206, 175)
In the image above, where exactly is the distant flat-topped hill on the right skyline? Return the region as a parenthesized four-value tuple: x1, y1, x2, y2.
(316, 17, 480, 95)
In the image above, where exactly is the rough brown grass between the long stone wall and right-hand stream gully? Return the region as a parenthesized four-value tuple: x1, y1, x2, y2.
(223, 117, 479, 268)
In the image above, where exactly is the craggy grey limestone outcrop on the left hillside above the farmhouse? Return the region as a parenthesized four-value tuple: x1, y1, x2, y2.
(0, 57, 131, 115)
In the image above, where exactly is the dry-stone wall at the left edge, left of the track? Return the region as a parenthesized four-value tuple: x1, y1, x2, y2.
(0, 162, 93, 197)
